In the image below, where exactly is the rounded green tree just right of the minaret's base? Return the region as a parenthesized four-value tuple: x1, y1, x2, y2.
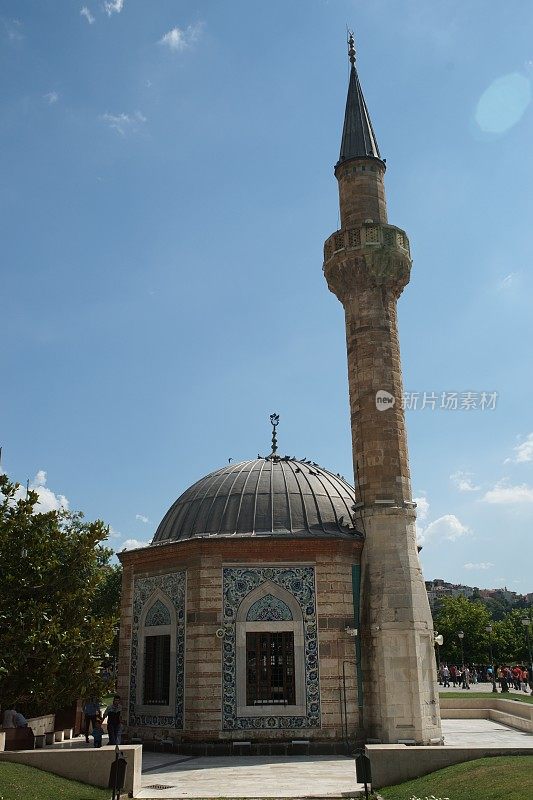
(433, 596, 492, 664)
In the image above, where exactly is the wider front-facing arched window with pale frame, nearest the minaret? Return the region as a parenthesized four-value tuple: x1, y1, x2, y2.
(236, 581, 306, 717)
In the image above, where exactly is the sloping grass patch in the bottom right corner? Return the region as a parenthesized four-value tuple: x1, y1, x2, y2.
(379, 756, 533, 800)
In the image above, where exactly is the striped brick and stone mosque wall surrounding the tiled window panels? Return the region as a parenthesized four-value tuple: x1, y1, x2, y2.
(118, 537, 362, 741)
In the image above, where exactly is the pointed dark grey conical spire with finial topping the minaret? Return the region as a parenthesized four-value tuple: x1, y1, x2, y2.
(338, 31, 381, 164)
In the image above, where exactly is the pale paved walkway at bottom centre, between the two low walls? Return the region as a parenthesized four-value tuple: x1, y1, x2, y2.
(137, 752, 363, 798)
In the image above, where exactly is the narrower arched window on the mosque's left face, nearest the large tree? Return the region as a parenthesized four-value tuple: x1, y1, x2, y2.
(136, 591, 176, 714)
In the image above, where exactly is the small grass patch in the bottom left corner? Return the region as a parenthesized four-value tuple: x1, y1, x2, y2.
(0, 761, 111, 800)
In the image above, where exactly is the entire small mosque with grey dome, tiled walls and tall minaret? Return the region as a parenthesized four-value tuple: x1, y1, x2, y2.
(118, 35, 442, 753)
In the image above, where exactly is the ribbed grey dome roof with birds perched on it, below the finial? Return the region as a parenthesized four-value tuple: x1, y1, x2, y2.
(152, 456, 360, 545)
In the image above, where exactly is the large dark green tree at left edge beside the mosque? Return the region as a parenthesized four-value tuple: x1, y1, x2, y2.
(0, 475, 119, 714)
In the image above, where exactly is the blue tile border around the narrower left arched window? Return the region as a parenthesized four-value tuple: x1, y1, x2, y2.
(129, 571, 186, 728)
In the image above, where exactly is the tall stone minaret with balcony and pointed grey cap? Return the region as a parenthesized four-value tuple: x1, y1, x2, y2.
(324, 34, 441, 744)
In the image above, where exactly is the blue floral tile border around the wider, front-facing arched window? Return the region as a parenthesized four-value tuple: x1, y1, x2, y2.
(222, 567, 320, 730)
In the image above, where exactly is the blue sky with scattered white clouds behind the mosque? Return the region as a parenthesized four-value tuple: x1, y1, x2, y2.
(0, 0, 533, 592)
